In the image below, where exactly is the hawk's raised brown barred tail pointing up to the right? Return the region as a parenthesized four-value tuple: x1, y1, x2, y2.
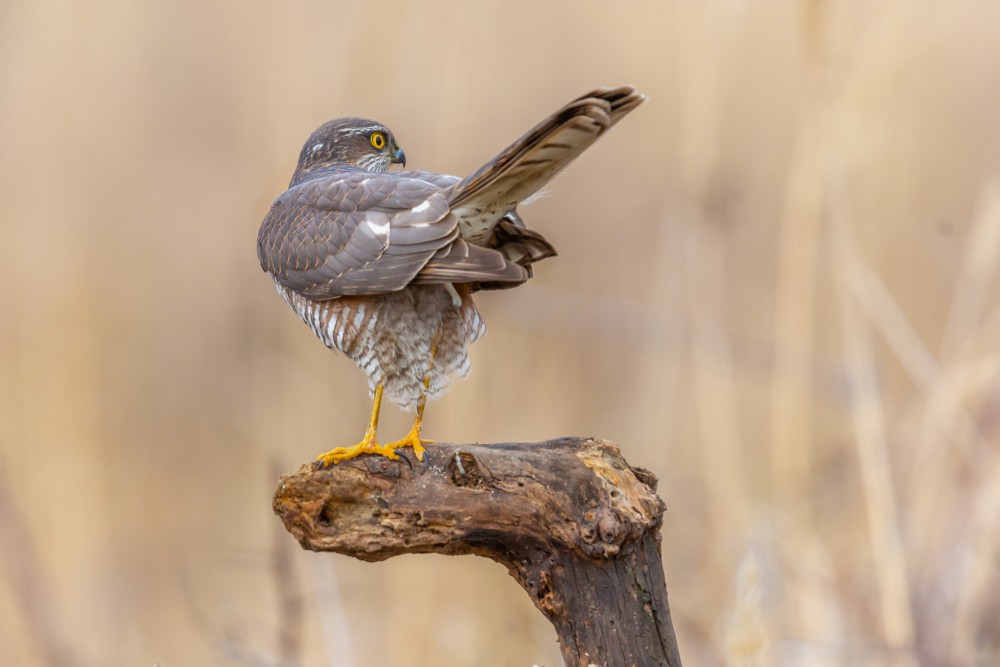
(448, 86, 646, 244)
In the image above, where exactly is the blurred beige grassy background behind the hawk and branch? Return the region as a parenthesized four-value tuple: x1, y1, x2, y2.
(0, 0, 1000, 667)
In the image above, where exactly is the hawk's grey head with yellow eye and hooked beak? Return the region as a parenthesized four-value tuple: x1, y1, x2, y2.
(293, 118, 406, 181)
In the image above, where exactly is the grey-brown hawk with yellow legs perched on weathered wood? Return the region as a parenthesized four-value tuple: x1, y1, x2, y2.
(257, 86, 646, 468)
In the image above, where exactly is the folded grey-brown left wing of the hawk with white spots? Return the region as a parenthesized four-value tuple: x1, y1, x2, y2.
(257, 171, 513, 299)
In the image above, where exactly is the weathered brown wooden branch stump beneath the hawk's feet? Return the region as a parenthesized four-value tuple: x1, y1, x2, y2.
(274, 438, 681, 667)
